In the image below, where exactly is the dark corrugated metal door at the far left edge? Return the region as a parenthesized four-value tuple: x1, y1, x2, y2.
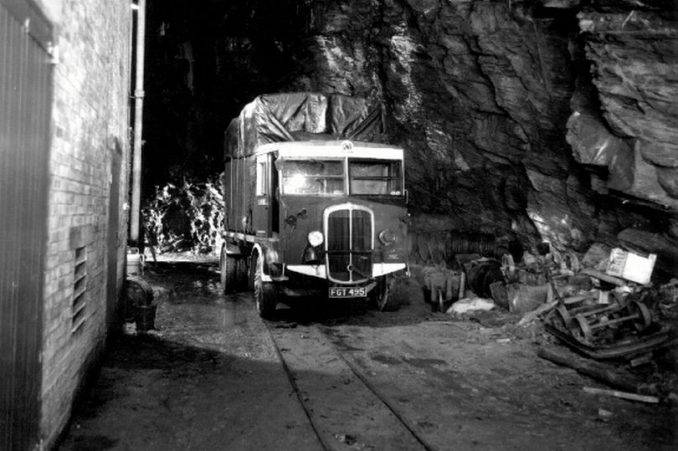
(0, 0, 52, 450)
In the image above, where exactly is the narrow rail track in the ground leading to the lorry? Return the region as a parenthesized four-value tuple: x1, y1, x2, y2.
(264, 314, 436, 451)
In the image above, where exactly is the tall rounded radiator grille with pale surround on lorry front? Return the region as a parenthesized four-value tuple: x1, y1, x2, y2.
(326, 208, 373, 282)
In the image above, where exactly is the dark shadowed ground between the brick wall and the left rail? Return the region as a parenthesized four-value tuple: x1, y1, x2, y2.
(58, 328, 326, 451)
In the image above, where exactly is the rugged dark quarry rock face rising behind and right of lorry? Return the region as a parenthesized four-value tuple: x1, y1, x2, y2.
(146, 0, 678, 258)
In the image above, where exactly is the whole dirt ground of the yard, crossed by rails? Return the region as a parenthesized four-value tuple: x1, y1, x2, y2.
(58, 261, 678, 451)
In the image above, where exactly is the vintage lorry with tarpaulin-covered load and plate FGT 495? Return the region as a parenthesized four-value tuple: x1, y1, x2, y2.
(220, 93, 409, 318)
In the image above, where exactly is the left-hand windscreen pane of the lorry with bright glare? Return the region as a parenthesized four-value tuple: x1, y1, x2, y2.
(282, 160, 345, 194)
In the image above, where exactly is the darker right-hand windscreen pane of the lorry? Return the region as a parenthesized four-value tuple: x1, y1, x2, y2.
(348, 159, 403, 196)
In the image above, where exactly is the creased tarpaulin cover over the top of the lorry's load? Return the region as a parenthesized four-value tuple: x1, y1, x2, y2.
(224, 92, 384, 157)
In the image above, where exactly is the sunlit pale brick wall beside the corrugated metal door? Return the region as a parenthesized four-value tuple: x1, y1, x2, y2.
(40, 0, 132, 449)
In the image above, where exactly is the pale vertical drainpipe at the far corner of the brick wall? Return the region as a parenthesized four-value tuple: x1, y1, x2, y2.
(130, 0, 146, 246)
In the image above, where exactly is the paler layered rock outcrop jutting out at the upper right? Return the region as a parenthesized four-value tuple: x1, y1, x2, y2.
(567, 5, 678, 210)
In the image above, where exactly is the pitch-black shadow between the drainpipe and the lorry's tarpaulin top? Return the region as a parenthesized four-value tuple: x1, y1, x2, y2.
(143, 0, 311, 192)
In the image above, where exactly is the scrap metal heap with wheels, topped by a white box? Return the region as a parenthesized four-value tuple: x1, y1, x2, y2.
(503, 245, 672, 365)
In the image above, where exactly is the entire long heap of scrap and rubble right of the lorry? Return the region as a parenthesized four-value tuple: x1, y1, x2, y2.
(423, 237, 678, 362)
